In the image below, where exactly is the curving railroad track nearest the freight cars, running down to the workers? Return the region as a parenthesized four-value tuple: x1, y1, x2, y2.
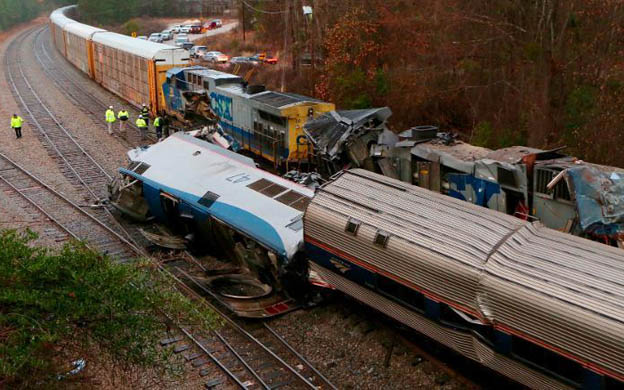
(33, 26, 156, 148)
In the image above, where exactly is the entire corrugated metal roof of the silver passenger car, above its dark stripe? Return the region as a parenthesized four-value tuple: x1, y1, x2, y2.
(304, 169, 624, 379)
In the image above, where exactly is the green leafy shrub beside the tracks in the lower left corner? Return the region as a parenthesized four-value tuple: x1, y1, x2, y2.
(0, 231, 215, 388)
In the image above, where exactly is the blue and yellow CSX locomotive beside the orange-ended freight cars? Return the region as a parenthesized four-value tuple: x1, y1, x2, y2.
(162, 66, 335, 166)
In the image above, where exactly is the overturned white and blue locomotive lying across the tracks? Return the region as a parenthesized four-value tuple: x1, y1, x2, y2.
(113, 133, 314, 274)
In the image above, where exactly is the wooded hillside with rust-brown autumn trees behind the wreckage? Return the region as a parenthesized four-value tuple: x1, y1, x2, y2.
(246, 0, 624, 166)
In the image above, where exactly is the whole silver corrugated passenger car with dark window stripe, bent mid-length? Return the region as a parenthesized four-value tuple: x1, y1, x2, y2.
(304, 170, 624, 389)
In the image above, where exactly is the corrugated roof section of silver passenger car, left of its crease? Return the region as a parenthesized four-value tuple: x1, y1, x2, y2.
(304, 169, 526, 315)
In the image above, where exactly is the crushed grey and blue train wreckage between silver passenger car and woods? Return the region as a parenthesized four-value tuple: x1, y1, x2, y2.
(385, 133, 624, 247)
